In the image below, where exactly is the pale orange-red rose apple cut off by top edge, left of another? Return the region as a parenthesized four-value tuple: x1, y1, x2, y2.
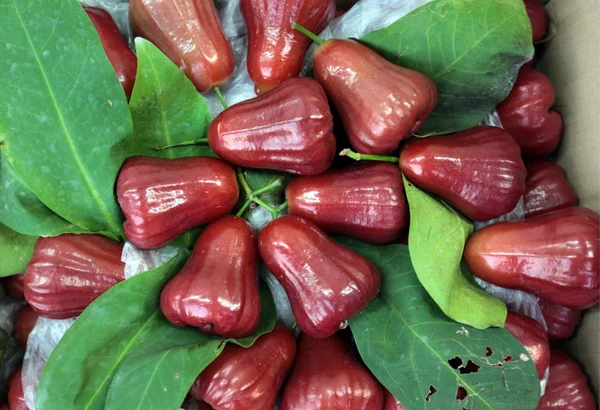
(129, 0, 235, 92)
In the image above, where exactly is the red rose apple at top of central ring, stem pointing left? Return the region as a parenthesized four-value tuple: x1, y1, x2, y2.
(208, 78, 336, 175)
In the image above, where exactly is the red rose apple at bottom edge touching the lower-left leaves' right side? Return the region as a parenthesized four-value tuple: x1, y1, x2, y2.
(190, 326, 296, 410)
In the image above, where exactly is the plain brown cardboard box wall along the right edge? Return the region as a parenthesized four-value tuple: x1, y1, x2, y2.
(539, 0, 600, 398)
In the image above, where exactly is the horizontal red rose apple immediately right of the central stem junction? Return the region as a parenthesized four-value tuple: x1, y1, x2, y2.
(285, 162, 408, 244)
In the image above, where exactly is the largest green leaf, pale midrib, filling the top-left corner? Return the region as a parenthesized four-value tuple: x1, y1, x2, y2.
(0, 0, 132, 235)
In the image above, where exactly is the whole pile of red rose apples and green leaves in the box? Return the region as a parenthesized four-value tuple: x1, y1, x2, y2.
(0, 0, 600, 410)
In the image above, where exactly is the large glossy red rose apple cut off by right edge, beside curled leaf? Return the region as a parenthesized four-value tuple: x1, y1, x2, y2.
(464, 207, 600, 309)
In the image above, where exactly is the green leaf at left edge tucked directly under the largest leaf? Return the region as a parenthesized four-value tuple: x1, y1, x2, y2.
(0, 153, 88, 236)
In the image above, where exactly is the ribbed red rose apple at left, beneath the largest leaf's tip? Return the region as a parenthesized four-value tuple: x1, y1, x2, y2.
(24, 234, 125, 319)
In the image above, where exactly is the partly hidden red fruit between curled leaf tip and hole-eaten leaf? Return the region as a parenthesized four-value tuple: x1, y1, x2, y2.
(504, 310, 550, 379)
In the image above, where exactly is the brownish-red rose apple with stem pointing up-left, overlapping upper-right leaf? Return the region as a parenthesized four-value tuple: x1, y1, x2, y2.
(314, 39, 437, 154)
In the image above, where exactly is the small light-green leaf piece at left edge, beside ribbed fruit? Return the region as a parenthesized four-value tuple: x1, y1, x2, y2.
(0, 224, 38, 276)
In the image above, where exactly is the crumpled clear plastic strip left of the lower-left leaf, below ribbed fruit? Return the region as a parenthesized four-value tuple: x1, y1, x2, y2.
(21, 317, 75, 409)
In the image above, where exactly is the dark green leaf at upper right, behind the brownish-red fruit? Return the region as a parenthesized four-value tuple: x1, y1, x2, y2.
(361, 0, 534, 134)
